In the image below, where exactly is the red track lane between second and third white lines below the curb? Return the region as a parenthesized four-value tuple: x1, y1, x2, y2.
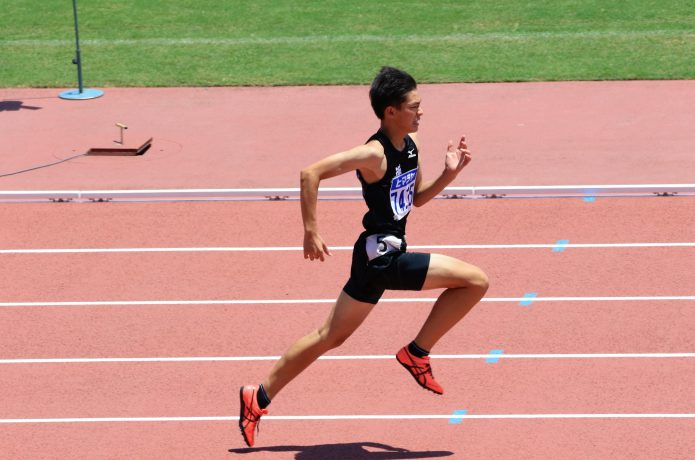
(0, 301, 695, 362)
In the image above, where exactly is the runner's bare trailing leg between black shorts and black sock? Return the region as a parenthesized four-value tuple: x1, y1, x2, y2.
(263, 291, 374, 399)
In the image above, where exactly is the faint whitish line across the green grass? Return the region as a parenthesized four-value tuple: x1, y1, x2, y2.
(0, 29, 693, 46)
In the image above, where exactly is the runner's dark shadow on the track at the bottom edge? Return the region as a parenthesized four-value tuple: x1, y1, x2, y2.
(229, 442, 454, 460)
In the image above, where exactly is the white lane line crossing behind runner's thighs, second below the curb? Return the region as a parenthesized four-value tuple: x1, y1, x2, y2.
(0, 295, 695, 308)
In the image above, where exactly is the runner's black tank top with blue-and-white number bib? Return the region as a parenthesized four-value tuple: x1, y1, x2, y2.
(357, 131, 418, 239)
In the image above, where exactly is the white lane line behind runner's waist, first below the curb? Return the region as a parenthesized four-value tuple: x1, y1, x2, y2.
(0, 242, 695, 254)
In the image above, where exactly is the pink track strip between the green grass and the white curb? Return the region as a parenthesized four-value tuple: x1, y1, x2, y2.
(0, 81, 695, 190)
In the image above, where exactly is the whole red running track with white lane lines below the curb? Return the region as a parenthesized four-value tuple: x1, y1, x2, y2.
(0, 82, 695, 459)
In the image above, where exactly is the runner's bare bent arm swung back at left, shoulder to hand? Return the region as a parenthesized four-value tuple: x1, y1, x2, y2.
(300, 144, 384, 262)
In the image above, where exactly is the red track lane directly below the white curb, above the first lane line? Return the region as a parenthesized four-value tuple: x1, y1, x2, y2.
(0, 198, 695, 249)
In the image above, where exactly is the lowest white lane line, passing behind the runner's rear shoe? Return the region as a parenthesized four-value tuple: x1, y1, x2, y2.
(0, 413, 695, 424)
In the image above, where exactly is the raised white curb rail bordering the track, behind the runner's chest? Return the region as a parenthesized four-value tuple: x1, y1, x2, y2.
(0, 184, 695, 201)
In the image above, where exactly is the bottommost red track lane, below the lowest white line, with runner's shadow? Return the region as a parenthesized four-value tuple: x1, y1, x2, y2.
(0, 420, 695, 460)
